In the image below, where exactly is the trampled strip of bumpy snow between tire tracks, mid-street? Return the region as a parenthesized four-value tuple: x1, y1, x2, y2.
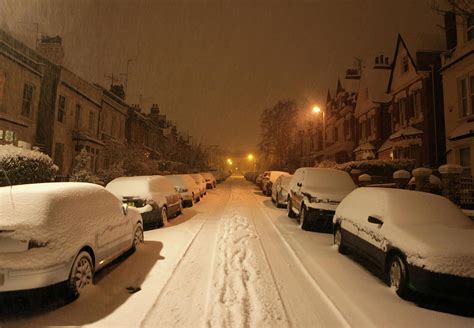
(205, 199, 289, 327)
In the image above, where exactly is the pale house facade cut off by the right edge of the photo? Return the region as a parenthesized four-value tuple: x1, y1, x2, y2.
(441, 13, 474, 176)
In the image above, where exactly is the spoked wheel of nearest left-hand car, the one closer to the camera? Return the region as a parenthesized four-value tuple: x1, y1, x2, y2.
(68, 251, 94, 296)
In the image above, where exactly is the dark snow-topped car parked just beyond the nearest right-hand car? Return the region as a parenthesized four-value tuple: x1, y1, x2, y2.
(287, 167, 357, 231)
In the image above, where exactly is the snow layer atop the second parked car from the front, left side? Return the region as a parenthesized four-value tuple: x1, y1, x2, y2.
(106, 175, 174, 199)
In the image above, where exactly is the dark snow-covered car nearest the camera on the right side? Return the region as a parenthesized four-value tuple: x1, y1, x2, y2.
(334, 187, 474, 304)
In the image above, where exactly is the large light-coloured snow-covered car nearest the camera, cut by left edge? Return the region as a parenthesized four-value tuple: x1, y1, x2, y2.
(0, 182, 143, 295)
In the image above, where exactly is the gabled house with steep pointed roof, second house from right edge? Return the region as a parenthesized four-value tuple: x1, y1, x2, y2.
(378, 35, 445, 167)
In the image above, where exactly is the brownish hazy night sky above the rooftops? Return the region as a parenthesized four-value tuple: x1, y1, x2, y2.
(0, 0, 442, 151)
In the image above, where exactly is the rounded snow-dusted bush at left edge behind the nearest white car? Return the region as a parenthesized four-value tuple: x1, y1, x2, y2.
(0, 145, 58, 185)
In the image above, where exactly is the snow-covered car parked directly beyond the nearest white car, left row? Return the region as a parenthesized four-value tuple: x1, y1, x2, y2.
(105, 175, 182, 227)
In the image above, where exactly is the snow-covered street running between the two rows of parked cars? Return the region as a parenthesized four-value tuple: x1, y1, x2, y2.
(0, 177, 474, 327)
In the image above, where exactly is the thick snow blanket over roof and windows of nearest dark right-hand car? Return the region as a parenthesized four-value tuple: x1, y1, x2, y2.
(336, 187, 474, 227)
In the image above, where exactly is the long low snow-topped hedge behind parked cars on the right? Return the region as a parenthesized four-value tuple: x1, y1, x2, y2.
(316, 159, 415, 176)
